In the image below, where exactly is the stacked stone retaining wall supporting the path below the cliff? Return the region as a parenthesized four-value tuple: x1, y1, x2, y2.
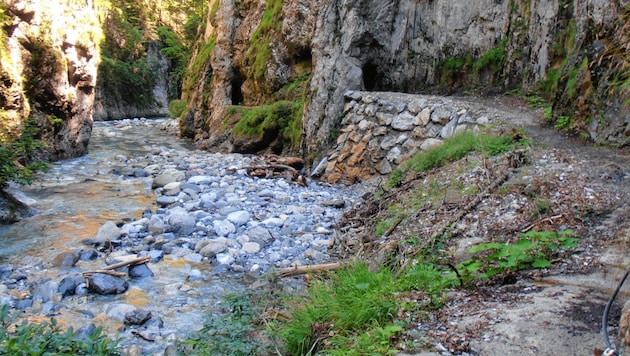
(313, 91, 508, 184)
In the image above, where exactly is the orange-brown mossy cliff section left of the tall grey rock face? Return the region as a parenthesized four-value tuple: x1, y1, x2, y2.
(180, 0, 320, 147)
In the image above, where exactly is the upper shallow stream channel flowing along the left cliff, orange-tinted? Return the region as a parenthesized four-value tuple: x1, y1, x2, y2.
(0, 119, 193, 262)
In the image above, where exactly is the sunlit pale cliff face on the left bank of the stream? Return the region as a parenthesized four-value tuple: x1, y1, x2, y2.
(0, 0, 101, 160)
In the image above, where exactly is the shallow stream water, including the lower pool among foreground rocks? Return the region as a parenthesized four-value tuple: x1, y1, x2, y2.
(0, 119, 238, 350)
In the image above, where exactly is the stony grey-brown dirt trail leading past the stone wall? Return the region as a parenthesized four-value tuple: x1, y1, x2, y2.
(346, 97, 630, 356)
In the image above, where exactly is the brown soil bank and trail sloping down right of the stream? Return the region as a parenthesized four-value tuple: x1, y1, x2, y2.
(341, 97, 630, 355)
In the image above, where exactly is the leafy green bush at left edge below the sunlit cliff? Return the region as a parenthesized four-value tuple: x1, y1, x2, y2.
(0, 120, 48, 188)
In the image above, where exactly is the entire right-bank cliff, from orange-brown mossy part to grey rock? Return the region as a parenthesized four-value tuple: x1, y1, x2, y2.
(181, 0, 630, 156)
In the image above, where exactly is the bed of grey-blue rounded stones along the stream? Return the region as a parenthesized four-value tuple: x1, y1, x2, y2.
(0, 120, 363, 354)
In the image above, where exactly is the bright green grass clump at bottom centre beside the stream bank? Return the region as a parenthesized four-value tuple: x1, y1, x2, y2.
(279, 263, 456, 355)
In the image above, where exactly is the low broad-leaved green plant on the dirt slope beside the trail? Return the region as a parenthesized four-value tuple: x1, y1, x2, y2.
(457, 230, 578, 280)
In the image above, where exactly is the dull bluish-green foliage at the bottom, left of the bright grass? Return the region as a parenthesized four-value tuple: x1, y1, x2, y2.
(177, 292, 276, 356)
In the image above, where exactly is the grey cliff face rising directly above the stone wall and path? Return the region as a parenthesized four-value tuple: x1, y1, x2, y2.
(304, 0, 630, 152)
